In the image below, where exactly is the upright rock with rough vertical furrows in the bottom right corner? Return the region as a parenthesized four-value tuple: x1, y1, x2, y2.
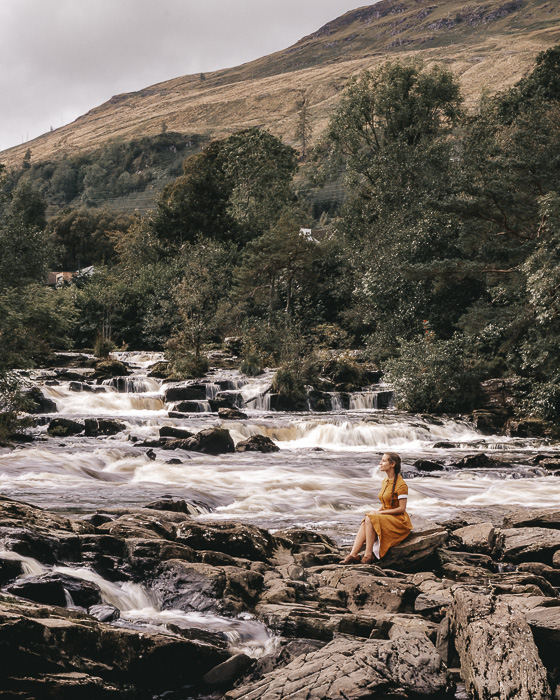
(452, 588, 550, 700)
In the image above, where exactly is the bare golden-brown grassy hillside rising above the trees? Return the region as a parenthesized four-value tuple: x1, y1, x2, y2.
(0, 0, 560, 170)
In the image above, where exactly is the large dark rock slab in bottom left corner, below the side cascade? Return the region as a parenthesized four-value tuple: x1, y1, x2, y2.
(0, 595, 229, 698)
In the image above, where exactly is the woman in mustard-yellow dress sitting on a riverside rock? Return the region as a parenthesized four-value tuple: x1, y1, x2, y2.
(340, 452, 412, 564)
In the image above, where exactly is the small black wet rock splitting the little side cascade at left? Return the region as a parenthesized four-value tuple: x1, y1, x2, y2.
(6, 573, 101, 608)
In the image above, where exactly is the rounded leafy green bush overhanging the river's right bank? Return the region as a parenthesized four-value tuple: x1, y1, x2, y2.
(385, 335, 481, 413)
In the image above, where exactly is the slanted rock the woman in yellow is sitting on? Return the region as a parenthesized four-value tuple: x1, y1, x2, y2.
(381, 517, 448, 571)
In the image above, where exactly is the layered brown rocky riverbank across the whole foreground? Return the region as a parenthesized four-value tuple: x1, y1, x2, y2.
(0, 498, 560, 700)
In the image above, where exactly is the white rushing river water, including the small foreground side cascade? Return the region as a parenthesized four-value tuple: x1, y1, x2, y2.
(0, 353, 560, 651)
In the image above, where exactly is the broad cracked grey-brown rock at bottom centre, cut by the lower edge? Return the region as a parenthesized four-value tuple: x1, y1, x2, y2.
(225, 633, 450, 700)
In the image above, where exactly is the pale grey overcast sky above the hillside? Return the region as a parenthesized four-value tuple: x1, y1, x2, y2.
(0, 0, 368, 150)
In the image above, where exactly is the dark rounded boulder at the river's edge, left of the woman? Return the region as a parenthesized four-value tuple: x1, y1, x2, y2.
(176, 520, 277, 561)
